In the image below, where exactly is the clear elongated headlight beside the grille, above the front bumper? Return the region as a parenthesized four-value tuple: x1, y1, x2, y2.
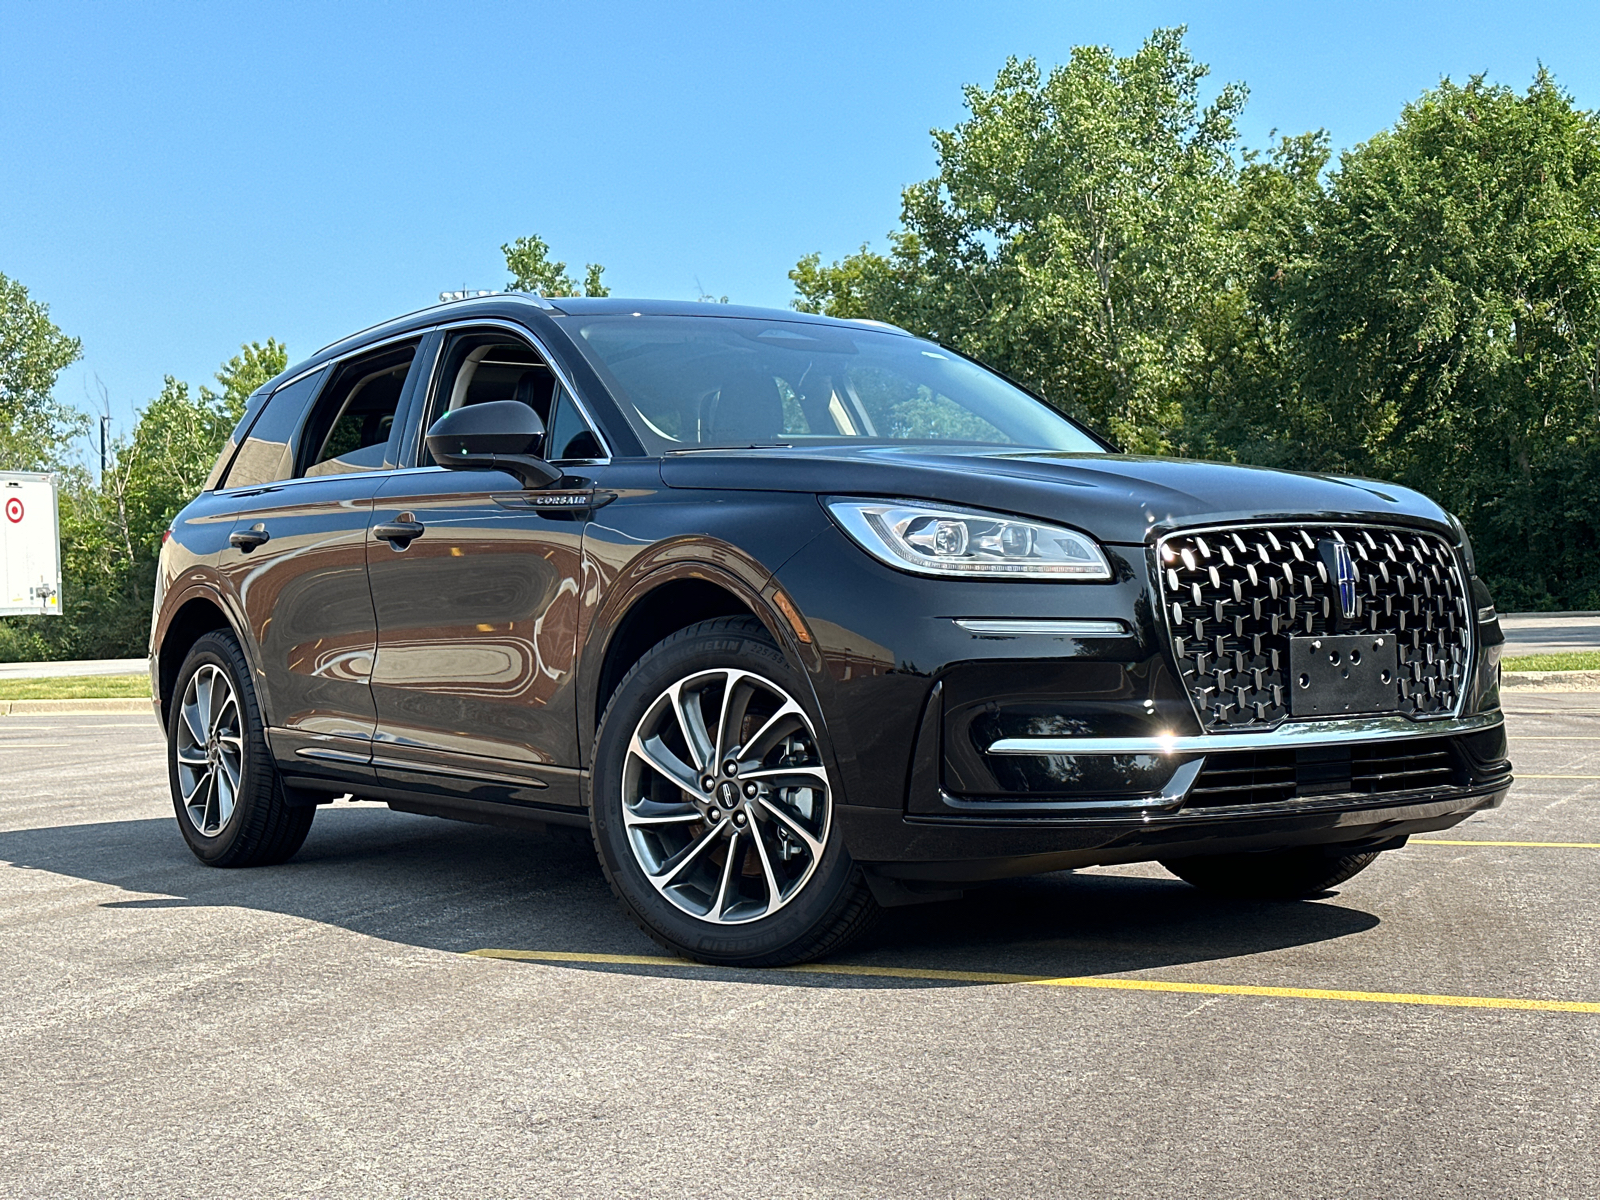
(822, 496, 1110, 579)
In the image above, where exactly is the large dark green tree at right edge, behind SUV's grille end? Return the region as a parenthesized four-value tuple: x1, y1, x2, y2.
(1283, 70, 1600, 608)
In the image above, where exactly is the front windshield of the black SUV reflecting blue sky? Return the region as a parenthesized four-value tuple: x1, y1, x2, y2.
(565, 315, 1102, 454)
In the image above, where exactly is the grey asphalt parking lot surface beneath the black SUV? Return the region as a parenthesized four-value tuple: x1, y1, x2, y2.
(0, 710, 1600, 1197)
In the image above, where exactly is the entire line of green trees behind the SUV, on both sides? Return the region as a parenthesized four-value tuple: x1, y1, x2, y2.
(0, 29, 1600, 661)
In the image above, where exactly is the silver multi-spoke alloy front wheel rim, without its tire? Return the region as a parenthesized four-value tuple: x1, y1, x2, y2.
(622, 669, 834, 925)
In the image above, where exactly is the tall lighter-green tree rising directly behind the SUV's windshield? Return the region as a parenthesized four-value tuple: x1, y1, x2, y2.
(790, 29, 1246, 450)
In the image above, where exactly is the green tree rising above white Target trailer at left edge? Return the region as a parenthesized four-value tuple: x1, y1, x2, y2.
(0, 275, 86, 470)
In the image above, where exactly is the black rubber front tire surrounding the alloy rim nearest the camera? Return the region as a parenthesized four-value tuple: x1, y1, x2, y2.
(589, 622, 858, 962)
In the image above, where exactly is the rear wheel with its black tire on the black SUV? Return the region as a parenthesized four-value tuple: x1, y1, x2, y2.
(166, 630, 317, 867)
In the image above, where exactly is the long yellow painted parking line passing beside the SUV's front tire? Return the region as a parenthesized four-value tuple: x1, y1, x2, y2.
(467, 950, 1600, 1014)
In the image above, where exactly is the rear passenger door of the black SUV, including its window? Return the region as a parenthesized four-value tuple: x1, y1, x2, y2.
(219, 338, 421, 790)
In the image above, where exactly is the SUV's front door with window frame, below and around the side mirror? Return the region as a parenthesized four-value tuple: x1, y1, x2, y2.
(366, 330, 603, 805)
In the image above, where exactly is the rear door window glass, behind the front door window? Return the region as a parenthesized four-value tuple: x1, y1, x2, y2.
(298, 342, 418, 477)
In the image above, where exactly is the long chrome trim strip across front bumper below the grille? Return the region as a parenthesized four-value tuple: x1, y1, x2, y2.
(987, 712, 1506, 755)
